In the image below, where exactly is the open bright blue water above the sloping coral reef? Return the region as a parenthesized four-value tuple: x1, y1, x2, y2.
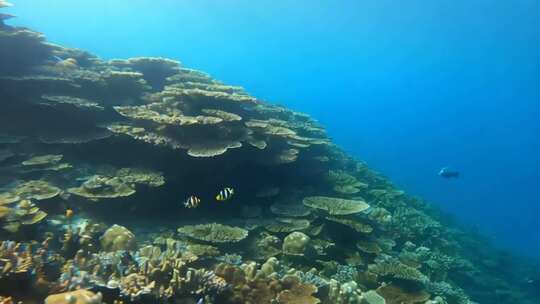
(9, 0, 540, 259)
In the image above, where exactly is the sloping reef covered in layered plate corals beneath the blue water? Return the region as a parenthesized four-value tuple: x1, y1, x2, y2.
(0, 0, 540, 304)
